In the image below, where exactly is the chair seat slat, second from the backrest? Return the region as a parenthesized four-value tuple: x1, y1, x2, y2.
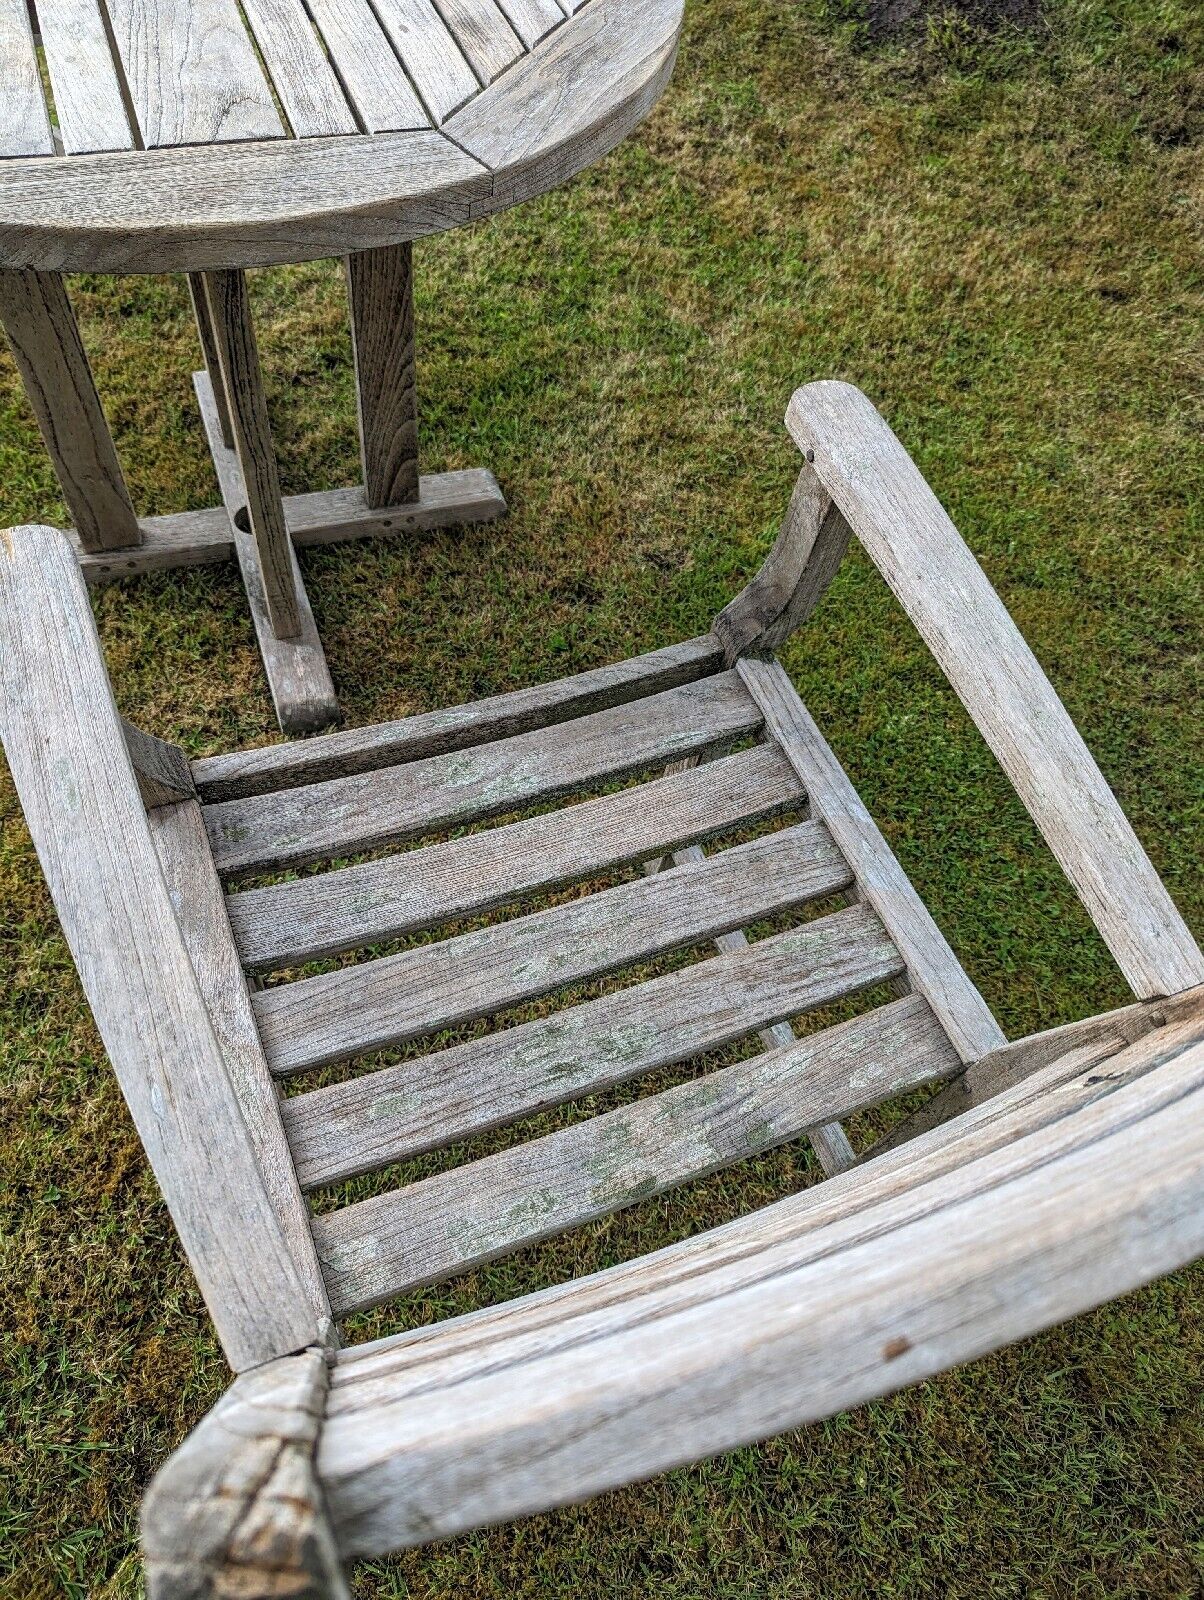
(282, 906, 903, 1189)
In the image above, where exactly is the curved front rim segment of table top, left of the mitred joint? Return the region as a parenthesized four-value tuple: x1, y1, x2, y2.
(0, 129, 493, 272)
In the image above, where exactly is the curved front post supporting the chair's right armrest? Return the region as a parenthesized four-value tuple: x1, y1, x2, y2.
(712, 467, 852, 664)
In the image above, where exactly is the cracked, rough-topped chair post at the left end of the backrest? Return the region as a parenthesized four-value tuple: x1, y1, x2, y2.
(141, 1350, 351, 1600)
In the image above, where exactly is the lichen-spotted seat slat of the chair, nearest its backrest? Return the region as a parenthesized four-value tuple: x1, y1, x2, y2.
(314, 995, 959, 1314)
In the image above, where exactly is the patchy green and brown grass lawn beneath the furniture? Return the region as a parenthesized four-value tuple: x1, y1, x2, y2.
(0, 0, 1204, 1600)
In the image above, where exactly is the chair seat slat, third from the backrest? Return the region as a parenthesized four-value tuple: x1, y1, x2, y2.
(253, 822, 852, 1074)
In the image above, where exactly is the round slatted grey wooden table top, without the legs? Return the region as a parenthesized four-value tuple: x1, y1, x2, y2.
(0, 0, 682, 272)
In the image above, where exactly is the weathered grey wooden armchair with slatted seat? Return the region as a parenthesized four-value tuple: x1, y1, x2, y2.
(0, 382, 1204, 1600)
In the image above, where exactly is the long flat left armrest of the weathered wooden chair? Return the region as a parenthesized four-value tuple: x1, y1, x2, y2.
(0, 528, 322, 1370)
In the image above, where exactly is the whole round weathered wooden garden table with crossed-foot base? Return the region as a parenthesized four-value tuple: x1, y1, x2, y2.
(0, 0, 680, 733)
